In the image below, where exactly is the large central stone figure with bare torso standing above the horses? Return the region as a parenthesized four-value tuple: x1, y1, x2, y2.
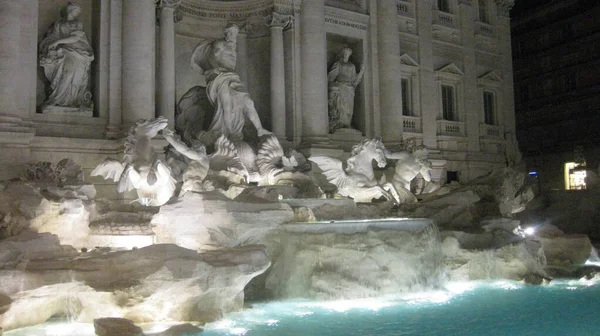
(185, 24, 271, 144)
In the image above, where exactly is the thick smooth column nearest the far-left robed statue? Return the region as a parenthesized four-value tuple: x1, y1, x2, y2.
(121, 0, 156, 124)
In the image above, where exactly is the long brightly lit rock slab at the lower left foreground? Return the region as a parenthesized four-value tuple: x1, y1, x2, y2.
(0, 234, 270, 330)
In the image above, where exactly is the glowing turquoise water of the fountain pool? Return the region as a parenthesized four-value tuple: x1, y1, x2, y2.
(5, 281, 600, 336)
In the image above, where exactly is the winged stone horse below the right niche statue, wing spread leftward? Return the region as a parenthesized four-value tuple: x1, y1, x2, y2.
(308, 138, 400, 203)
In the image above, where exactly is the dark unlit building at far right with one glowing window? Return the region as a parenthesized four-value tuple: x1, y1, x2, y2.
(512, 0, 600, 190)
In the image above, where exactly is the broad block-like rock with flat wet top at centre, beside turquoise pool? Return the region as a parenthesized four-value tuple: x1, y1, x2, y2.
(250, 219, 445, 300)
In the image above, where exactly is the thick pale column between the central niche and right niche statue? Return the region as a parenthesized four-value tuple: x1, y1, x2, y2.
(300, 0, 328, 143)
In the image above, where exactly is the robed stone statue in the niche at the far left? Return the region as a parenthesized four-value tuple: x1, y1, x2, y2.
(39, 2, 94, 111)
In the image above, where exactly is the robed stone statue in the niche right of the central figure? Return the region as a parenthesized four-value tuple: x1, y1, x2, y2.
(327, 47, 364, 133)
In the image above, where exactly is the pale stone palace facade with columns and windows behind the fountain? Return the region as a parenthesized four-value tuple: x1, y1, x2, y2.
(0, 0, 515, 197)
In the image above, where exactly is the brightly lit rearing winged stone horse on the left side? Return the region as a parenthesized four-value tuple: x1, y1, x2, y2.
(91, 117, 175, 206)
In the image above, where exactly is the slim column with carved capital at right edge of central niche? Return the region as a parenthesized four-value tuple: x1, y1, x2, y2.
(268, 12, 291, 139)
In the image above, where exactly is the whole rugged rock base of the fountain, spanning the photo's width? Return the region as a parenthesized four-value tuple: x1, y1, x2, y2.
(0, 164, 591, 330)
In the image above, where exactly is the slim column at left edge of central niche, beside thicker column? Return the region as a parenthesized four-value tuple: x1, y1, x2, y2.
(158, 0, 181, 127)
